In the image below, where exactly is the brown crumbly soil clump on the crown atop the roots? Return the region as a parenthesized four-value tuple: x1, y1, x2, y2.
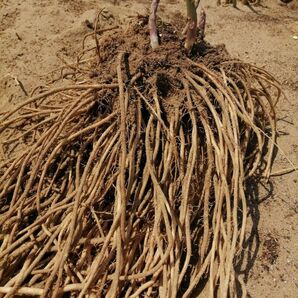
(86, 17, 231, 94)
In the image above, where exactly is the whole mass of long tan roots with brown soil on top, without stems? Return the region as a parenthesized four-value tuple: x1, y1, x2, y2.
(0, 18, 280, 297)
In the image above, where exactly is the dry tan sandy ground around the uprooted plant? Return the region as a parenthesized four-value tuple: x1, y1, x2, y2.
(0, 0, 298, 298)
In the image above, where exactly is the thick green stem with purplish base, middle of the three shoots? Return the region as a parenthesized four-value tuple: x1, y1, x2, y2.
(184, 0, 199, 50)
